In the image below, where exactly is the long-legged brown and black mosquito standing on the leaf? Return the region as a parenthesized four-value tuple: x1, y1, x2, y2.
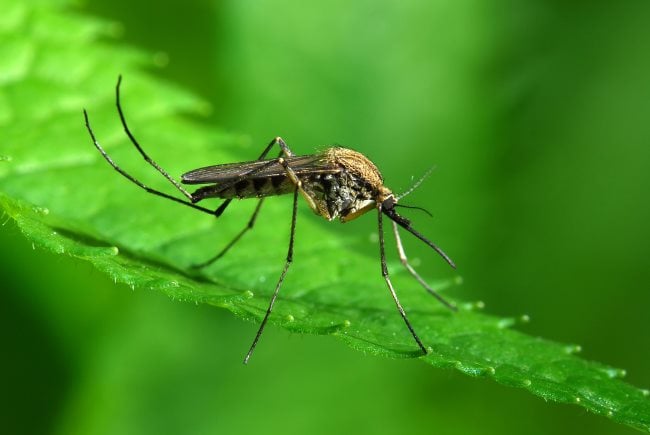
(83, 76, 456, 364)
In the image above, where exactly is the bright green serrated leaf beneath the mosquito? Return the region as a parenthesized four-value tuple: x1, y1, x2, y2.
(0, 1, 650, 430)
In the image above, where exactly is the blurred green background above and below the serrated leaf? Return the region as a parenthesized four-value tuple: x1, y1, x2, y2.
(0, 0, 650, 434)
